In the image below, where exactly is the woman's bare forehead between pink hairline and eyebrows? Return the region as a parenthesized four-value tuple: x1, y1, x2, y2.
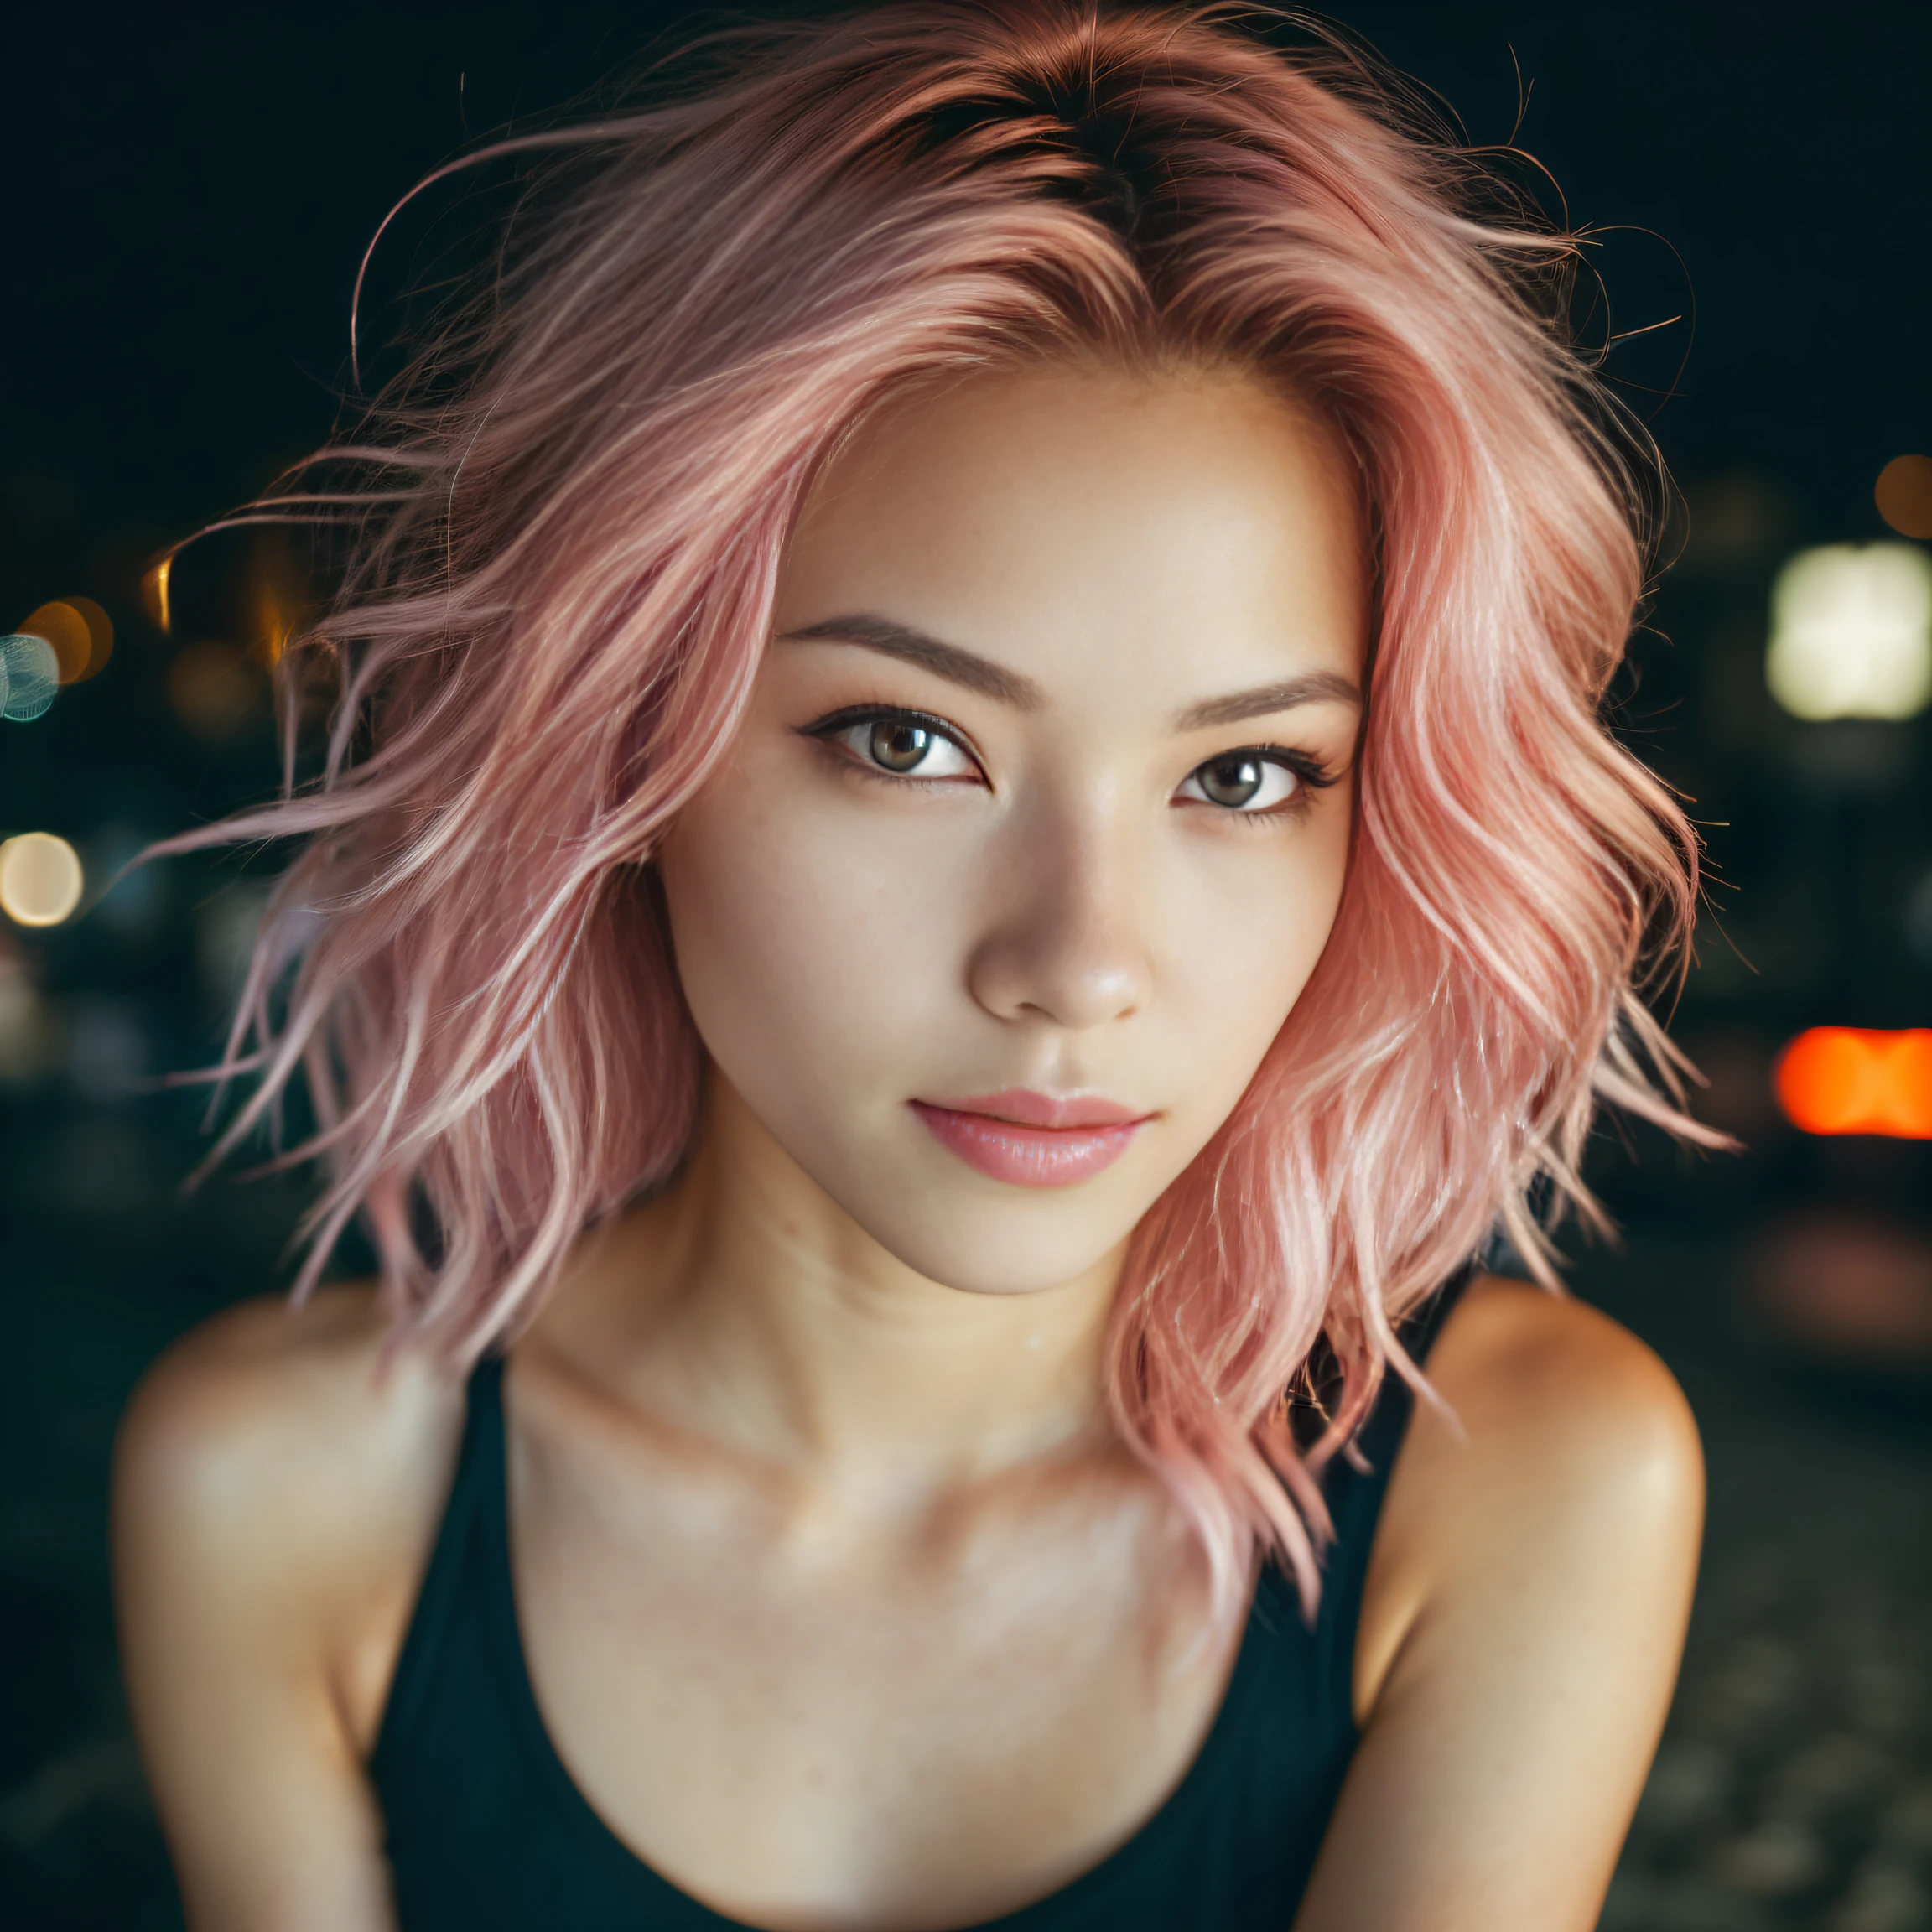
(779, 365, 1366, 699)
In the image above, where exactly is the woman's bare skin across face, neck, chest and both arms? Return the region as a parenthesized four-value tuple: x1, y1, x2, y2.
(116, 369, 1701, 1932)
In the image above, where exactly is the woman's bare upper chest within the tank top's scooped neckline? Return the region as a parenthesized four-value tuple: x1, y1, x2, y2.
(508, 1406, 1239, 1932)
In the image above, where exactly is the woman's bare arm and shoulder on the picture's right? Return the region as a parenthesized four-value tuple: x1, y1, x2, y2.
(1296, 1283, 1702, 1932)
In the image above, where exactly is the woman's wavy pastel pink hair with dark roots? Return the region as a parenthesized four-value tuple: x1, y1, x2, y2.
(162, 0, 1698, 1612)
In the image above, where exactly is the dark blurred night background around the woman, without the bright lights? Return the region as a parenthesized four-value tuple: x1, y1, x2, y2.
(0, 4, 1932, 1932)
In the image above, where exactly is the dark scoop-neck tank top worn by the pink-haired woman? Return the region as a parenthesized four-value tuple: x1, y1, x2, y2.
(369, 1277, 1467, 1932)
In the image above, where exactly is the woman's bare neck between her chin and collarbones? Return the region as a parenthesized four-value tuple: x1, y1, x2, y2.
(564, 1076, 1123, 1495)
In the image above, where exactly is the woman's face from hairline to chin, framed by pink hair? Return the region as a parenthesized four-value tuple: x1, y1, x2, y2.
(661, 367, 1366, 1292)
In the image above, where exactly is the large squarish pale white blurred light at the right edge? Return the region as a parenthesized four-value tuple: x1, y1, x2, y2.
(1764, 543, 1932, 719)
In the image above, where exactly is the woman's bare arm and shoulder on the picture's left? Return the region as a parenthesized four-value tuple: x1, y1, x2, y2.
(114, 1292, 460, 1932)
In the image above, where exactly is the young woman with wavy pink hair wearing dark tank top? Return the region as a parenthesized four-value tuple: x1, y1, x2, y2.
(116, 0, 1701, 1932)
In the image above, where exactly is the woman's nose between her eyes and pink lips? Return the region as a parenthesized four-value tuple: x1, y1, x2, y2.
(968, 796, 1153, 1030)
